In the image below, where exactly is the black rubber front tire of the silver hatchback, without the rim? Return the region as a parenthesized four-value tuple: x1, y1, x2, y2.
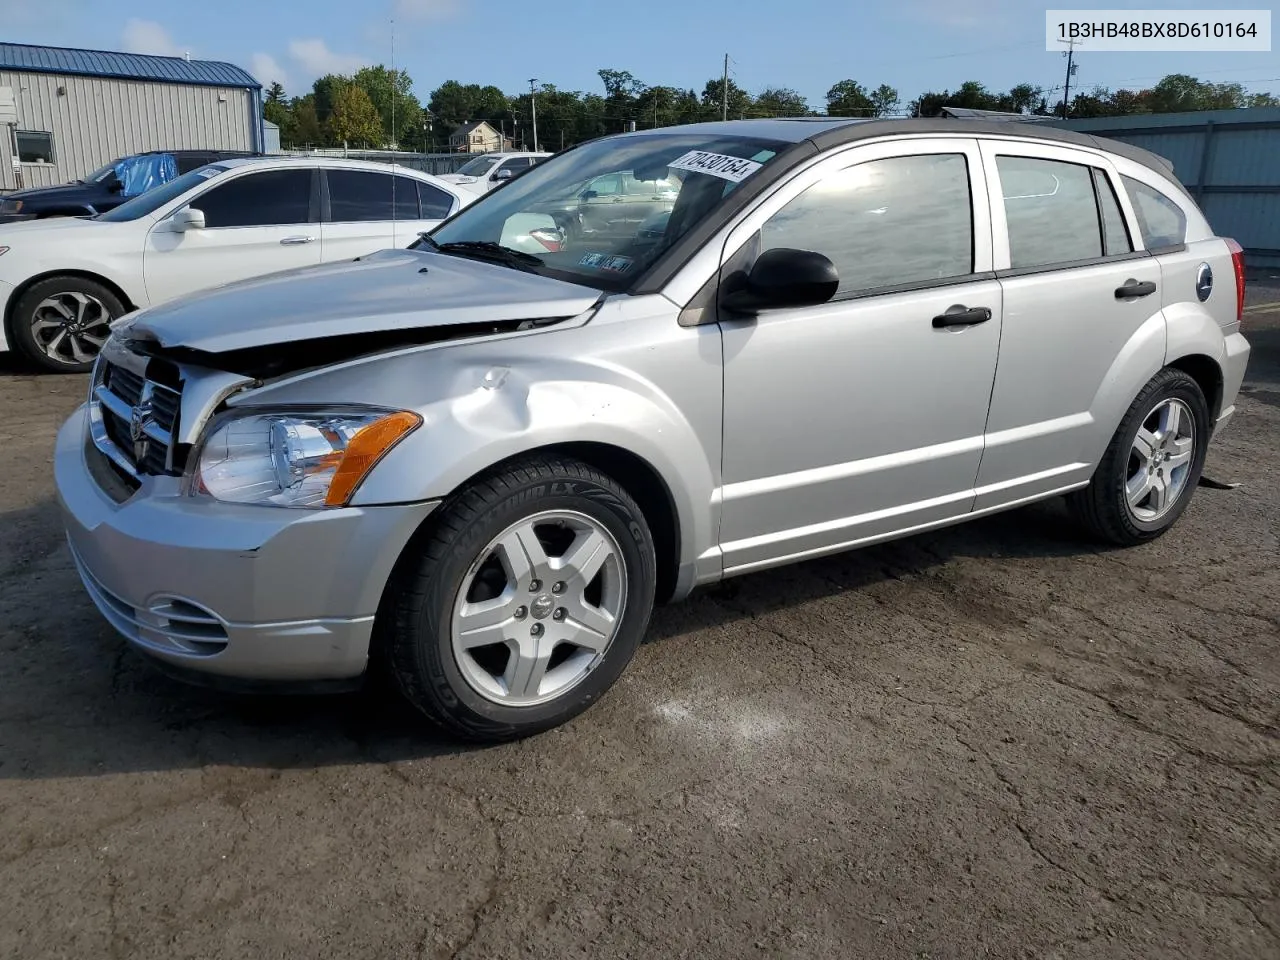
(378, 456, 657, 741)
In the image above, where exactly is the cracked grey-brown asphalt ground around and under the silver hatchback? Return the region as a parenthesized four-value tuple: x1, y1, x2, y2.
(0, 287, 1280, 960)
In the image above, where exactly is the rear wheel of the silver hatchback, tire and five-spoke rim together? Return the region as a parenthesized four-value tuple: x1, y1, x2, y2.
(1070, 367, 1212, 547)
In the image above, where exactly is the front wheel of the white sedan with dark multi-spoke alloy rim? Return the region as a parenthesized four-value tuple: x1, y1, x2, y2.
(13, 276, 125, 374)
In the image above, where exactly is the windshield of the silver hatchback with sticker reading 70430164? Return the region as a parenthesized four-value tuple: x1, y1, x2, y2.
(424, 132, 787, 291)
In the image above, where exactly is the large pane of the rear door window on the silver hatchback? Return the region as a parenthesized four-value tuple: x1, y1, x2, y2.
(996, 156, 1102, 269)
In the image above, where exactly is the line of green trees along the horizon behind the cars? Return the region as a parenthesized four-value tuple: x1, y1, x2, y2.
(262, 65, 1280, 152)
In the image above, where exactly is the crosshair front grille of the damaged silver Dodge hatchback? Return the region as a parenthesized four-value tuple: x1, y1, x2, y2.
(90, 360, 180, 477)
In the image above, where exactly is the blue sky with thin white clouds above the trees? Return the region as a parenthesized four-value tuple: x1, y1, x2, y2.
(0, 0, 1280, 109)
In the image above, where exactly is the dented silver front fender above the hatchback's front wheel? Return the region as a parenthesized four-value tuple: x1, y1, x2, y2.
(233, 310, 722, 583)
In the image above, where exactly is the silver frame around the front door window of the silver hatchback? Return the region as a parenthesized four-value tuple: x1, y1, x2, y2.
(701, 137, 995, 302)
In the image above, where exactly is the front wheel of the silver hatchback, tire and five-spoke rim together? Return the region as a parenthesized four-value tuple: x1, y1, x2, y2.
(380, 457, 657, 741)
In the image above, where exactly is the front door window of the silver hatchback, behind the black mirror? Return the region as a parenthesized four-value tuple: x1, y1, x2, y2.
(760, 154, 973, 297)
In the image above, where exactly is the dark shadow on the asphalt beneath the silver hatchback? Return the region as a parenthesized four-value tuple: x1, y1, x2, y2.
(0, 502, 1116, 781)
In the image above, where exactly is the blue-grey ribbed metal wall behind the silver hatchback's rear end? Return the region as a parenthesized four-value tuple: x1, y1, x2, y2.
(1056, 108, 1280, 268)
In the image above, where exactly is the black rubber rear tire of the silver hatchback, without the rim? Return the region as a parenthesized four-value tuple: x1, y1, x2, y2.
(1068, 367, 1213, 547)
